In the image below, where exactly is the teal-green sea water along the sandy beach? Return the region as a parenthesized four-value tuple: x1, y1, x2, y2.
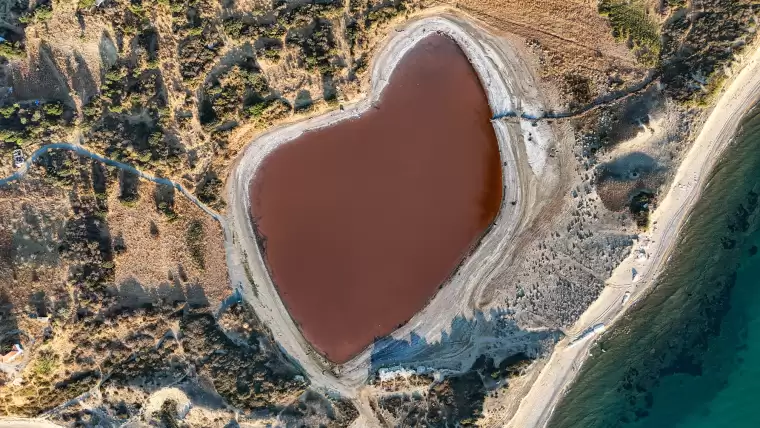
(548, 106, 760, 428)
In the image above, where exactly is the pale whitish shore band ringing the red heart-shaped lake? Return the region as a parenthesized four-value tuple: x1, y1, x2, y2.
(227, 10, 552, 404)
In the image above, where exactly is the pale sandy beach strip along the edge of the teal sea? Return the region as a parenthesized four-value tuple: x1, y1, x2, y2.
(507, 42, 760, 428)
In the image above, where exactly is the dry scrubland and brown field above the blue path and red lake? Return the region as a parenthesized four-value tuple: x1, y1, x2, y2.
(0, 0, 646, 199)
